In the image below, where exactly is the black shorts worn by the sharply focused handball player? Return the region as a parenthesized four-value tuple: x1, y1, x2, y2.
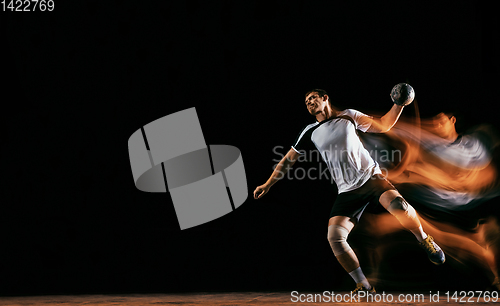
(330, 174, 396, 221)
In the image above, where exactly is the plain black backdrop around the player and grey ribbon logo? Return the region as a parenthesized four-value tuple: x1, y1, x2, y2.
(0, 0, 498, 295)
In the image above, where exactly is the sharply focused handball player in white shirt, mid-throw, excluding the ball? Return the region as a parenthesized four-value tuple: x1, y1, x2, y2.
(254, 89, 445, 292)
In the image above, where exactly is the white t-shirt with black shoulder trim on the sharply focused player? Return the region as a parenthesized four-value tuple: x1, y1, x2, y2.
(292, 109, 382, 193)
